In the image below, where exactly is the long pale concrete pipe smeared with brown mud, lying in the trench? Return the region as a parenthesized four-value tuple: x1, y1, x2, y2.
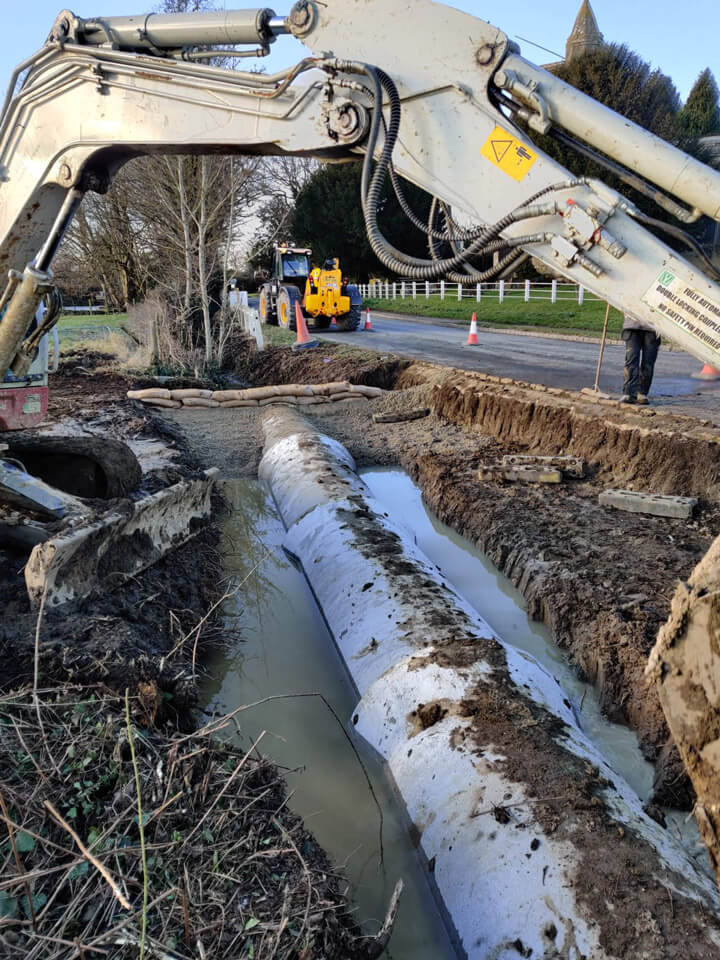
(259, 407, 720, 960)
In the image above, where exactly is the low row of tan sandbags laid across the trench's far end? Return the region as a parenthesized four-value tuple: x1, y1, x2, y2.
(127, 380, 385, 407)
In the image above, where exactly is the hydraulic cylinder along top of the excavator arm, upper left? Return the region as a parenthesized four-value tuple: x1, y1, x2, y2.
(50, 7, 287, 50)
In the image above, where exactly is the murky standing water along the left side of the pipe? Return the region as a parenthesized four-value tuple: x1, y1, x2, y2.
(198, 480, 456, 960)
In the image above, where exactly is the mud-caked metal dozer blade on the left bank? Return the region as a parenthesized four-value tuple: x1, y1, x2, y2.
(25, 468, 219, 607)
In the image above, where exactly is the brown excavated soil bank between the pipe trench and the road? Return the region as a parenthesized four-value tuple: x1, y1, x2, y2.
(170, 345, 720, 809)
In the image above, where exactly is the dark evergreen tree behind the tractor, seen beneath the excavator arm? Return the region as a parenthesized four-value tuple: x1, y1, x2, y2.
(293, 162, 430, 282)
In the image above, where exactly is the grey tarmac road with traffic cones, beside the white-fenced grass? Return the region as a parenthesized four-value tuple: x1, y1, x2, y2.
(313, 312, 720, 415)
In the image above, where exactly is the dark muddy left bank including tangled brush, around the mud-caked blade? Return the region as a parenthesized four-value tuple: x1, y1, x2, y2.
(0, 352, 372, 960)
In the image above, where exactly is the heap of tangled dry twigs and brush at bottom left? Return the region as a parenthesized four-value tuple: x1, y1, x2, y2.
(0, 687, 368, 960)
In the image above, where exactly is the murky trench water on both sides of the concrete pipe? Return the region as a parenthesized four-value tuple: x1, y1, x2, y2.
(195, 468, 706, 960)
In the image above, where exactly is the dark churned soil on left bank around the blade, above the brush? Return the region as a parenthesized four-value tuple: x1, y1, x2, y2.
(0, 353, 222, 712)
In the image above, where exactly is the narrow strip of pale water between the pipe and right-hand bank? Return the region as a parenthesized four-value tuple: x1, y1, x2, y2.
(359, 467, 712, 876)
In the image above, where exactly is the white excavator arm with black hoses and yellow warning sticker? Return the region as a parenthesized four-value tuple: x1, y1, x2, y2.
(0, 0, 720, 374)
